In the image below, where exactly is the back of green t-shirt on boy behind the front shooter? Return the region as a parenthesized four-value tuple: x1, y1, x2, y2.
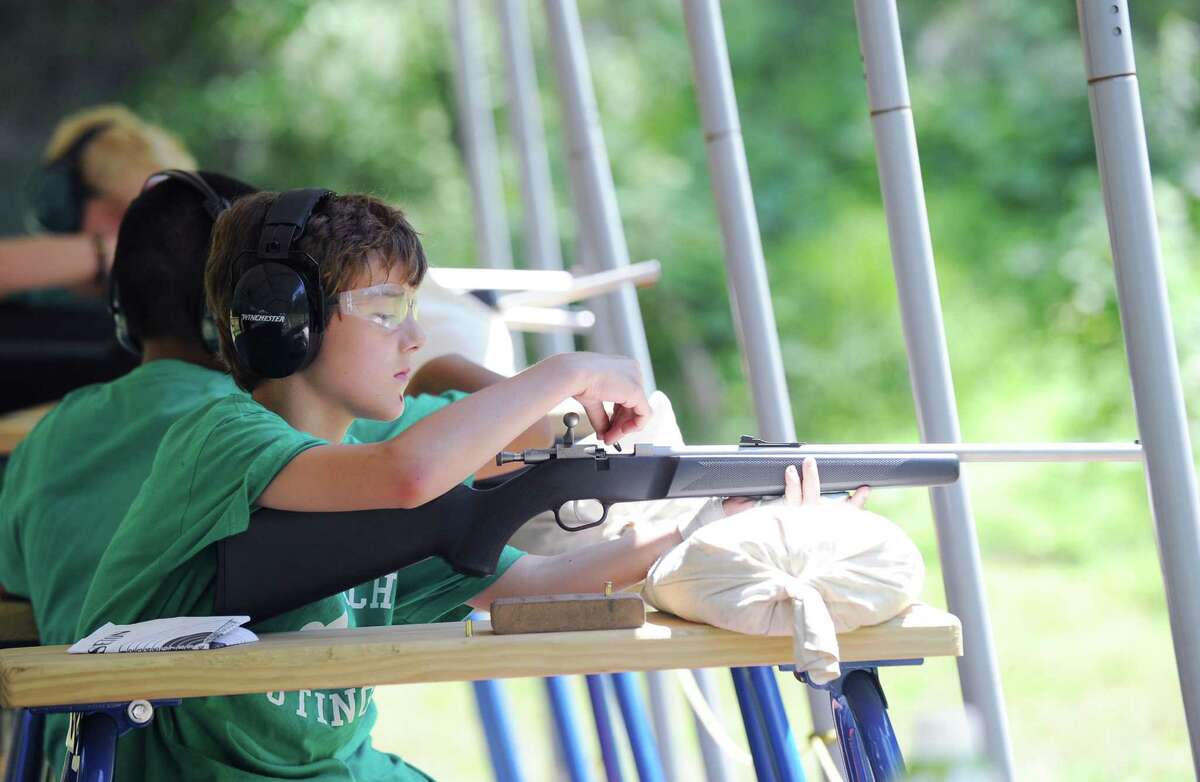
(0, 359, 236, 644)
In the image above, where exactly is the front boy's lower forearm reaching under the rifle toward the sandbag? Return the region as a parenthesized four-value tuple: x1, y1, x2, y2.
(469, 527, 683, 608)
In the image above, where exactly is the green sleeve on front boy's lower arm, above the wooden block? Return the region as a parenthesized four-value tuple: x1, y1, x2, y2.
(391, 546, 524, 625)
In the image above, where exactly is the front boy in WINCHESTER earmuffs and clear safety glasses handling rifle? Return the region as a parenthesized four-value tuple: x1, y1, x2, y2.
(77, 192, 705, 780)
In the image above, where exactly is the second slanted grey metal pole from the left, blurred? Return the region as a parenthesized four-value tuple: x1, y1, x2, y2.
(496, 0, 575, 359)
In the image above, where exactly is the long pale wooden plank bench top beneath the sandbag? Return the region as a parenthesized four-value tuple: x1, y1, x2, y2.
(0, 604, 962, 708)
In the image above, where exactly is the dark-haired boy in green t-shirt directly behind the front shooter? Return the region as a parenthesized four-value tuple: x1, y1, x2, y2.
(0, 173, 530, 768)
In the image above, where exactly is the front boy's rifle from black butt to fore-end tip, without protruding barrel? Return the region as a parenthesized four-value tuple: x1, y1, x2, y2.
(215, 414, 959, 620)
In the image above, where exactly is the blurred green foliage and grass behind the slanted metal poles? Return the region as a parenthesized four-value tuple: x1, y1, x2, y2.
(0, 0, 1200, 780)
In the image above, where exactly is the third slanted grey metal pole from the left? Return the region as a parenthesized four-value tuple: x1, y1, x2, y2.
(546, 0, 655, 389)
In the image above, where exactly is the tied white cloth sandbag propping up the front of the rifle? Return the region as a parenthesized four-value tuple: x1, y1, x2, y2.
(642, 503, 925, 684)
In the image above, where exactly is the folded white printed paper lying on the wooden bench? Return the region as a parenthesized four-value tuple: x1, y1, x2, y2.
(67, 616, 258, 655)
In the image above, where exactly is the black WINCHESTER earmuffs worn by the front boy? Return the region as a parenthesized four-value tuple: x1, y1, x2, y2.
(229, 190, 332, 378)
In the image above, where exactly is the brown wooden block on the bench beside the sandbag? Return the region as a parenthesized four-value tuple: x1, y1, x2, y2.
(492, 592, 646, 636)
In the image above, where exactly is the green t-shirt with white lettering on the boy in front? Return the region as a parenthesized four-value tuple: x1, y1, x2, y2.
(77, 395, 521, 781)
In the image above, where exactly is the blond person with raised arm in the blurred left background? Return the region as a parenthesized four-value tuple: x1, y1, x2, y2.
(0, 104, 196, 411)
